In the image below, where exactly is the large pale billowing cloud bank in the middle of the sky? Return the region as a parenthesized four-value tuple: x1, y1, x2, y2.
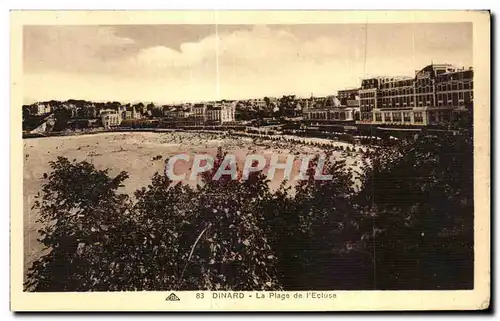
(131, 26, 346, 69)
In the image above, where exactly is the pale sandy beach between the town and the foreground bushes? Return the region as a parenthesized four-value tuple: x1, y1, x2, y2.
(23, 132, 359, 269)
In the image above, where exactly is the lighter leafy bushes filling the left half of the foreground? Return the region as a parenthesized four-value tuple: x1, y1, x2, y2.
(25, 153, 280, 291)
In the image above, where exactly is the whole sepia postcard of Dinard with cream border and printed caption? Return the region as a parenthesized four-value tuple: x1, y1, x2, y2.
(11, 11, 490, 311)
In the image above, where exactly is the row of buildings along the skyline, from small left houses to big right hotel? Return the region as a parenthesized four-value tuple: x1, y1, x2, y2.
(23, 64, 474, 127)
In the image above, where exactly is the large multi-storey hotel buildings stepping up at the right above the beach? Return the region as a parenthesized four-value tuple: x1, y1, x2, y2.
(304, 64, 474, 126)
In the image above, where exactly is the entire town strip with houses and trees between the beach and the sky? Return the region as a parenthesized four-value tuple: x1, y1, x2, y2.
(23, 63, 474, 139)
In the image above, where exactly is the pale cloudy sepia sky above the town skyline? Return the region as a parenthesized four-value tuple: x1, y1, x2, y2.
(23, 23, 472, 103)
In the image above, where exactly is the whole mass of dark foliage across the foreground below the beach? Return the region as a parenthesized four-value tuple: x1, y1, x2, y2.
(25, 135, 474, 291)
